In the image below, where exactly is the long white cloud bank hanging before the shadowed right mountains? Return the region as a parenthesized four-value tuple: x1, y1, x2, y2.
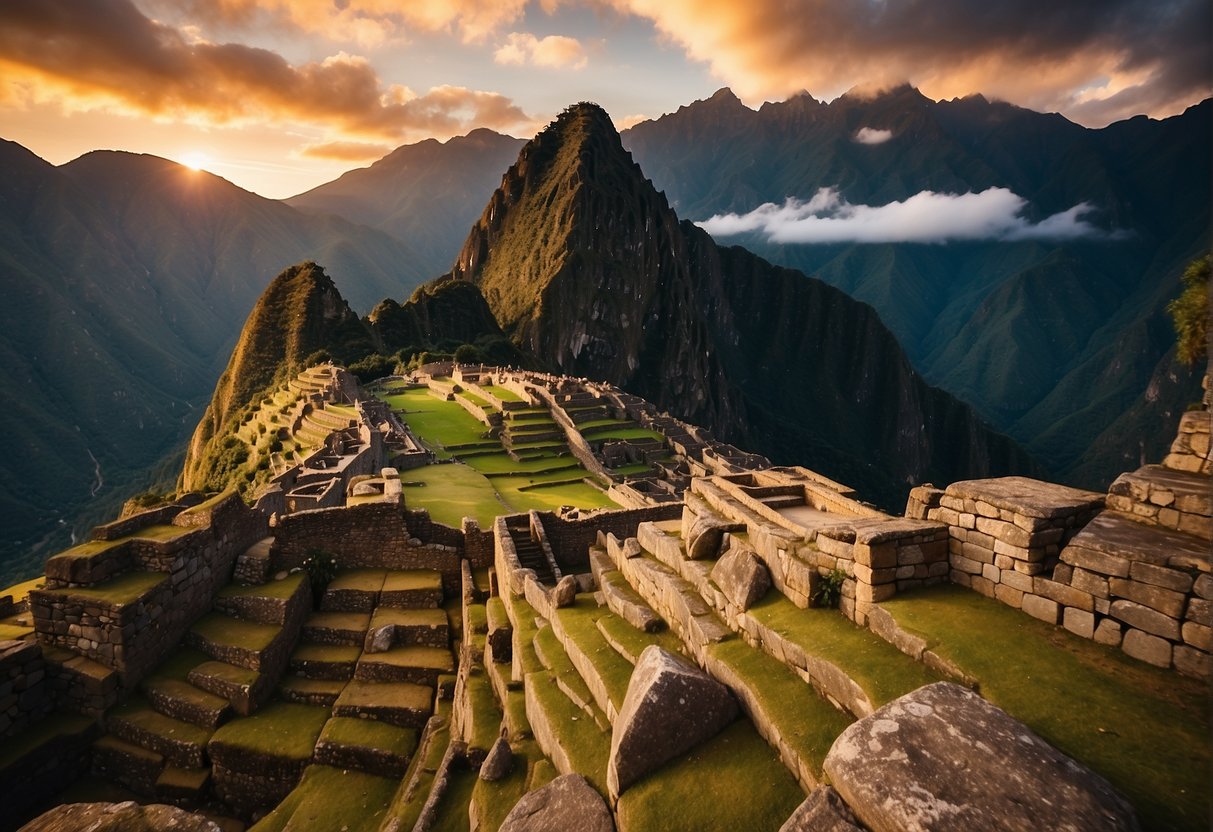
(696, 188, 1120, 243)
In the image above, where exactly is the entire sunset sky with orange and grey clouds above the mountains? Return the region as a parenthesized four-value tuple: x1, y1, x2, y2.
(0, 0, 1213, 198)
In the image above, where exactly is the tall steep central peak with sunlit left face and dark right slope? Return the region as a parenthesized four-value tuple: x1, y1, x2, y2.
(452, 104, 1038, 505)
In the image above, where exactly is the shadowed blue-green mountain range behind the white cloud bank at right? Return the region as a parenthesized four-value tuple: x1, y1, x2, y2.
(623, 87, 1213, 489)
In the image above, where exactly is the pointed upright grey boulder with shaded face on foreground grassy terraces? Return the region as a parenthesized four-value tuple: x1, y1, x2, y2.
(607, 644, 738, 800)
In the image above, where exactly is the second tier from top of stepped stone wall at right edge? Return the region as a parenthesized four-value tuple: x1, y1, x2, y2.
(1107, 465, 1213, 541)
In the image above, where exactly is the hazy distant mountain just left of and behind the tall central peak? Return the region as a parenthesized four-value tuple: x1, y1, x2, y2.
(285, 127, 525, 277)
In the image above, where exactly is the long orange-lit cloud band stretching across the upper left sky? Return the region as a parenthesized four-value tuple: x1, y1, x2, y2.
(0, 0, 533, 139)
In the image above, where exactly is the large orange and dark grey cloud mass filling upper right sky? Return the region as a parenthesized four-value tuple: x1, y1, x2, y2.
(603, 0, 1213, 124)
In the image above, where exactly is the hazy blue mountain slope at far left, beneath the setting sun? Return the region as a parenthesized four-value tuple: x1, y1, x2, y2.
(0, 142, 421, 582)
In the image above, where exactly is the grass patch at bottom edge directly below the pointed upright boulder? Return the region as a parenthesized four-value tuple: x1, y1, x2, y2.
(616, 719, 804, 832)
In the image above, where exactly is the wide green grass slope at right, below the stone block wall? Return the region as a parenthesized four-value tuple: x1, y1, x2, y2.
(881, 586, 1211, 830)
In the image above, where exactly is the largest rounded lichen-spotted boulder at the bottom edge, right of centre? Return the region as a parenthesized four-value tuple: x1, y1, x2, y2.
(825, 682, 1140, 832)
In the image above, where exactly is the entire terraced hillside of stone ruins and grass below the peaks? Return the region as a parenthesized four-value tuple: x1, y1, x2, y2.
(0, 363, 1213, 832)
